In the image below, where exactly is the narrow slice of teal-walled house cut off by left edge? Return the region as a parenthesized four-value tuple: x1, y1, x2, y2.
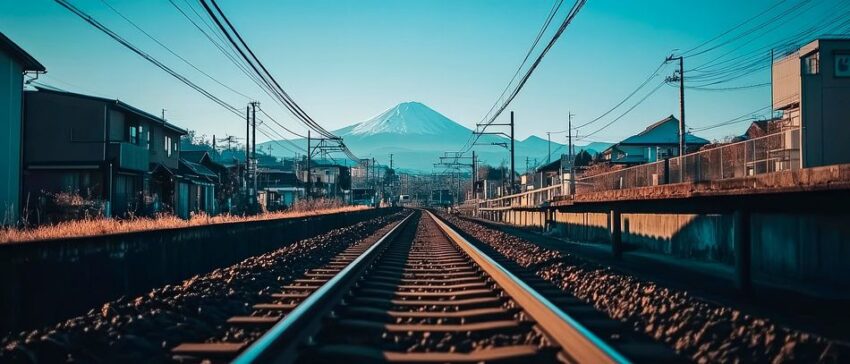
(0, 33, 46, 225)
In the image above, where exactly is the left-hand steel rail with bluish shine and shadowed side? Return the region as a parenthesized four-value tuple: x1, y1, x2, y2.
(233, 213, 415, 364)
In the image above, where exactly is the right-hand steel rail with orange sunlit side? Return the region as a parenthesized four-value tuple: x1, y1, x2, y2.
(427, 211, 630, 363)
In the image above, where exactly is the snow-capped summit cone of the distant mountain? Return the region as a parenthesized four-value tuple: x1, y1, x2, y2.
(349, 101, 468, 135)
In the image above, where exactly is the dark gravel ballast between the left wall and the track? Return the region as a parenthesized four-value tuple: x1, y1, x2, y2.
(0, 213, 403, 363)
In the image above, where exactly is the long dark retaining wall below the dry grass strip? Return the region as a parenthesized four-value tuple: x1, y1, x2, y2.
(0, 208, 398, 335)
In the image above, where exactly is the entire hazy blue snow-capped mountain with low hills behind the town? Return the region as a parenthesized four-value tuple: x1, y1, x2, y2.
(258, 102, 607, 173)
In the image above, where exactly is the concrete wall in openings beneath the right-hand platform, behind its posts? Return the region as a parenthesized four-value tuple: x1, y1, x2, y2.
(482, 211, 850, 296)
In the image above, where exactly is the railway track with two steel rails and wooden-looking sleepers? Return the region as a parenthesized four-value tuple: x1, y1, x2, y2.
(172, 211, 628, 363)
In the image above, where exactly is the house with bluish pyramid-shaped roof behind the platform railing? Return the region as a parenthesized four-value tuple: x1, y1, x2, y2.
(602, 115, 709, 165)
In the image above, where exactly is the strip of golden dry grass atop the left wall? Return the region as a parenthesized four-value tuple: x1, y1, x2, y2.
(0, 200, 368, 244)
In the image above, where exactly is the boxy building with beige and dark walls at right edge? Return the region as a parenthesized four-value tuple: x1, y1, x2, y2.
(771, 38, 850, 167)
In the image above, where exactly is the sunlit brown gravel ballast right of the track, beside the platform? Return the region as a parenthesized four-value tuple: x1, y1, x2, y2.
(443, 215, 850, 363)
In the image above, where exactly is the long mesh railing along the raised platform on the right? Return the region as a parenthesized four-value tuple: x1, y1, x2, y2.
(479, 128, 801, 209)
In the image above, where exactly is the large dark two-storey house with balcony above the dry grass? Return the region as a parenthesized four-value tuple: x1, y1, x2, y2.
(23, 87, 189, 217)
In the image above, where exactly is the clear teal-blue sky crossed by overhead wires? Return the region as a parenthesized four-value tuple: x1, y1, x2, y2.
(0, 0, 848, 149)
